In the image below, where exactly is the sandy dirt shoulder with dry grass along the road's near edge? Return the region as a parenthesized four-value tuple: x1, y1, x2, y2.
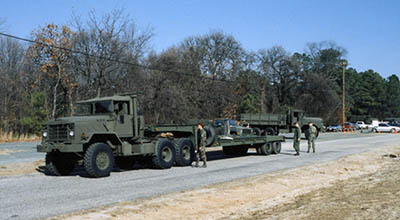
(51, 147, 400, 220)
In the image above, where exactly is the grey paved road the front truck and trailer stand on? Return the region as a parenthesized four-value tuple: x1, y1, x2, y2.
(0, 133, 400, 219)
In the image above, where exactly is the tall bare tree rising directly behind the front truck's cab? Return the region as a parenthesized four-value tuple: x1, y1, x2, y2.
(72, 10, 153, 96)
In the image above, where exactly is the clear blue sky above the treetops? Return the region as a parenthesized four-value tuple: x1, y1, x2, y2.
(0, 0, 400, 78)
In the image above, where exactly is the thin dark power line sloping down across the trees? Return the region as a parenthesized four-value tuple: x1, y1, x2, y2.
(0, 32, 233, 83)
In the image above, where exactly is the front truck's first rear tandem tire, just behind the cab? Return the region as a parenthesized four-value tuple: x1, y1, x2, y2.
(152, 139, 175, 169)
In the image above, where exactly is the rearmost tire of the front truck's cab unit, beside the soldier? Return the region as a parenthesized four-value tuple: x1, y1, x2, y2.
(175, 139, 194, 166)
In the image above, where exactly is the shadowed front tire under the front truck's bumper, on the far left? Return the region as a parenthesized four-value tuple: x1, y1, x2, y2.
(45, 152, 76, 176)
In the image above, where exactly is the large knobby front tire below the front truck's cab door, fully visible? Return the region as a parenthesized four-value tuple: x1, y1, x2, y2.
(83, 143, 114, 177)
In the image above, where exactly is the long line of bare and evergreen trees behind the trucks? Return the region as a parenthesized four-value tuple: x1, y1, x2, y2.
(0, 10, 400, 137)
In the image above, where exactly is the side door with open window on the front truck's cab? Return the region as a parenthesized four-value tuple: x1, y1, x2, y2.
(114, 101, 133, 137)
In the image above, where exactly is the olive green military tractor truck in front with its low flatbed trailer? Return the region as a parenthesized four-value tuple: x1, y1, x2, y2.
(37, 95, 284, 177)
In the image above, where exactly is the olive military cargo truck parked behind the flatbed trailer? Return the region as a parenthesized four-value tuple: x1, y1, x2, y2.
(240, 110, 323, 136)
